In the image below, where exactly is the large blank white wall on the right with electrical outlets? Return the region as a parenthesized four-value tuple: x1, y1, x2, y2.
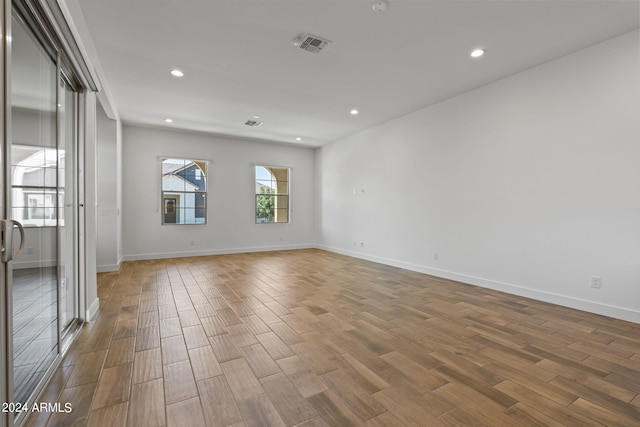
(316, 31, 640, 323)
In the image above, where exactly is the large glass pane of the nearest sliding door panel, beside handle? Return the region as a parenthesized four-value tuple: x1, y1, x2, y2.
(7, 8, 59, 402)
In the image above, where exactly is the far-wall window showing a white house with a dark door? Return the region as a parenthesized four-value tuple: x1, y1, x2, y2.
(162, 158, 207, 224)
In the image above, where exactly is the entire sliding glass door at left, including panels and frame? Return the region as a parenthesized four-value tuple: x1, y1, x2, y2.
(0, 2, 79, 425)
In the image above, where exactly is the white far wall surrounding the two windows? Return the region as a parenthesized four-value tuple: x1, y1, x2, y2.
(123, 125, 315, 260)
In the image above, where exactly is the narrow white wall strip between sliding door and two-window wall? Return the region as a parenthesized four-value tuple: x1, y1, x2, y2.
(96, 103, 120, 272)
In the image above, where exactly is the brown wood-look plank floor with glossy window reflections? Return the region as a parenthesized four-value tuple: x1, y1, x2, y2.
(22, 250, 640, 427)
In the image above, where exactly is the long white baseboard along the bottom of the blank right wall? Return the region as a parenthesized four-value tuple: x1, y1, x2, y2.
(315, 245, 640, 324)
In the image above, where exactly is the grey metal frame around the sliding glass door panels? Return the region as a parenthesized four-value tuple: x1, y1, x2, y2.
(0, 0, 99, 427)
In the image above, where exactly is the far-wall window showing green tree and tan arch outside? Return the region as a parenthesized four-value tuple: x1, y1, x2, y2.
(255, 166, 289, 223)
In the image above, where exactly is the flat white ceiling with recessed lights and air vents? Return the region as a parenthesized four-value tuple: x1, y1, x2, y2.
(79, 0, 640, 146)
